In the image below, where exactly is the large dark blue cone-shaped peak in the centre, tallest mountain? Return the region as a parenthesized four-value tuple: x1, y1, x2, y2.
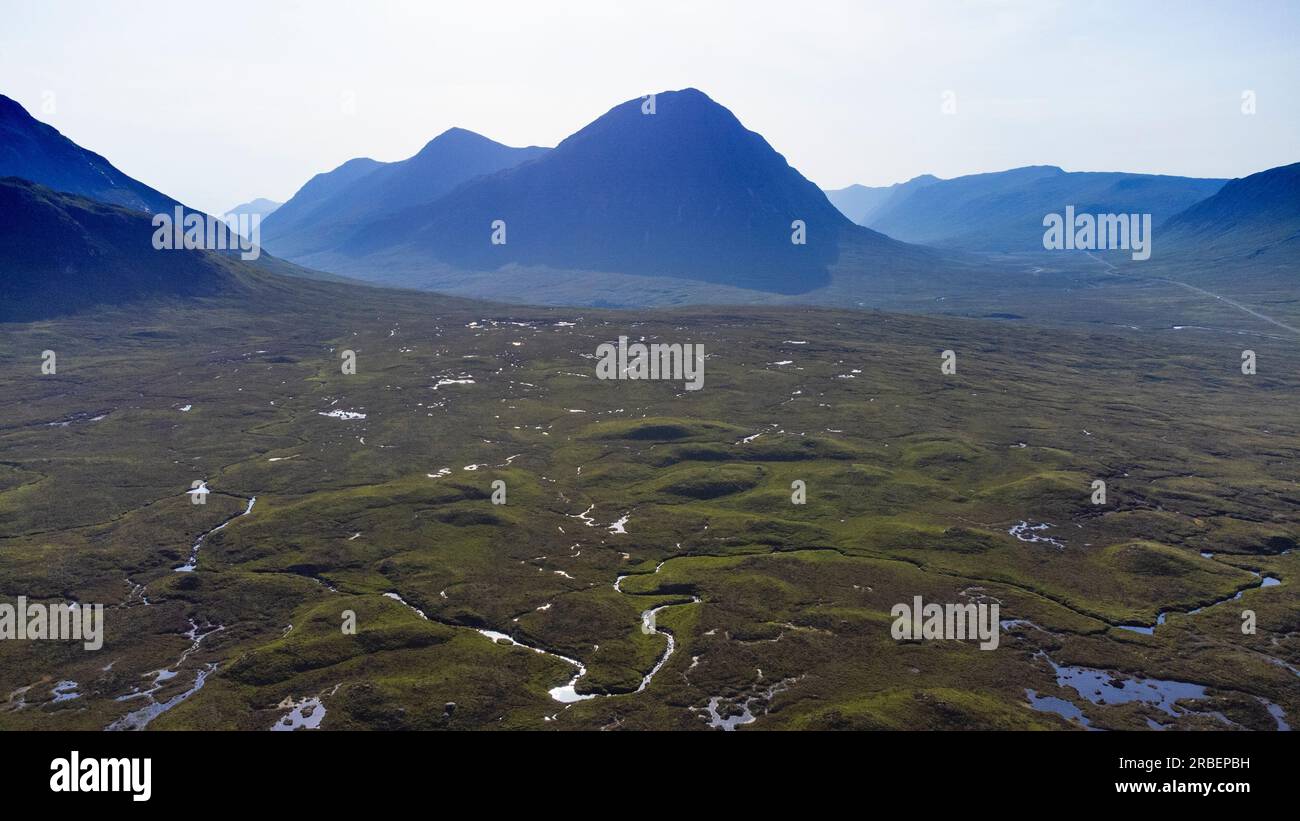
(325, 88, 920, 293)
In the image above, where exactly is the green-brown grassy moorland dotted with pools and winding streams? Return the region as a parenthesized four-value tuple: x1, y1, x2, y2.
(0, 282, 1300, 730)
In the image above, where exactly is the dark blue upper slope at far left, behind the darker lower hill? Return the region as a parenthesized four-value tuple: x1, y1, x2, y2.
(0, 95, 178, 213)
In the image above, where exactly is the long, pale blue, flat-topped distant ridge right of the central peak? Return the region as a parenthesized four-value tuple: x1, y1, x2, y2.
(868, 165, 1223, 251)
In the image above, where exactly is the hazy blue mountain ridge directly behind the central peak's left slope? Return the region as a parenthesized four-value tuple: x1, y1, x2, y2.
(263, 129, 547, 257)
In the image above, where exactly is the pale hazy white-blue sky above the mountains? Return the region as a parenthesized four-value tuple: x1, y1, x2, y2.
(0, 0, 1300, 212)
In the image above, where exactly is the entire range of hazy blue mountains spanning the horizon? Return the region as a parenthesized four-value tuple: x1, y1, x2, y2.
(0, 88, 1300, 318)
